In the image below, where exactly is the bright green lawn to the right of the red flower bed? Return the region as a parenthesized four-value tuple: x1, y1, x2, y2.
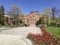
(46, 26, 60, 38)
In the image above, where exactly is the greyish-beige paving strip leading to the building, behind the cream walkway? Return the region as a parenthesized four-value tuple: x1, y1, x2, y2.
(0, 27, 42, 36)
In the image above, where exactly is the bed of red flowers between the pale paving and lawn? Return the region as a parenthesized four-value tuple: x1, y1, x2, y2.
(27, 28, 57, 45)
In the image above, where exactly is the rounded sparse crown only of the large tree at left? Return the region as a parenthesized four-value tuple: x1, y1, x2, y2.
(8, 5, 22, 16)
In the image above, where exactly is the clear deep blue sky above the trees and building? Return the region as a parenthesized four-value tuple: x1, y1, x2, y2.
(0, 0, 60, 14)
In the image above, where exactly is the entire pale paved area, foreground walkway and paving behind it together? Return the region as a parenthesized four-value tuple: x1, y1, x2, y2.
(0, 27, 43, 45)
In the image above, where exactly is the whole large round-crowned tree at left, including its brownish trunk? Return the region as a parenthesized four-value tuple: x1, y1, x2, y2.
(8, 5, 22, 25)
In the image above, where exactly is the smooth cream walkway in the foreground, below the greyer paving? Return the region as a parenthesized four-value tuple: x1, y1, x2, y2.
(0, 34, 32, 45)
